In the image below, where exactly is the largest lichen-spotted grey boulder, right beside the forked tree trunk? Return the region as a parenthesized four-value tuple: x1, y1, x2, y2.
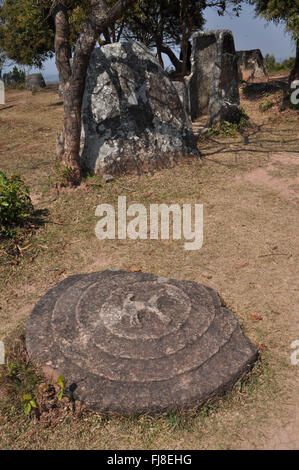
(81, 42, 198, 175)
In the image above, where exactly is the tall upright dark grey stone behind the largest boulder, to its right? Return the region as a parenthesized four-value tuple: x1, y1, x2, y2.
(190, 30, 241, 126)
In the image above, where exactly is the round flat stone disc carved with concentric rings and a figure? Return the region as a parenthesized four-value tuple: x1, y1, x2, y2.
(26, 271, 258, 414)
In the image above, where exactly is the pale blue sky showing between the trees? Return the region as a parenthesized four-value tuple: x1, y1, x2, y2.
(8, 5, 295, 77)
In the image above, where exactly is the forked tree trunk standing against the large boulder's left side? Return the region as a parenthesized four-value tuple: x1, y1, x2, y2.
(54, 0, 136, 185)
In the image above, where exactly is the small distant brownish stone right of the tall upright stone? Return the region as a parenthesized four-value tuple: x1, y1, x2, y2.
(237, 49, 268, 82)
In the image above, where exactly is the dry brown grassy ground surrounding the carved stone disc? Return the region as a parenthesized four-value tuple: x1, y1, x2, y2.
(0, 79, 299, 449)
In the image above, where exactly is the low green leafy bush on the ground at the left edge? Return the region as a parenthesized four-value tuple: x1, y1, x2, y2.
(0, 171, 33, 237)
